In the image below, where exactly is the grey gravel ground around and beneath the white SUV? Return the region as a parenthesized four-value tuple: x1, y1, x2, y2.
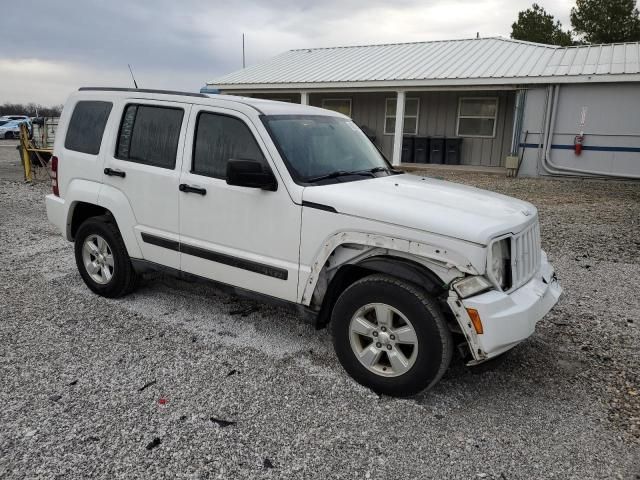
(0, 149, 640, 479)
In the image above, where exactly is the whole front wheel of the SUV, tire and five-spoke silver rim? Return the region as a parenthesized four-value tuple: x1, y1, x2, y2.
(331, 275, 453, 396)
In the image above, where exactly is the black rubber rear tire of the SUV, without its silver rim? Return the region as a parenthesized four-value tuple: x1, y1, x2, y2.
(75, 215, 138, 298)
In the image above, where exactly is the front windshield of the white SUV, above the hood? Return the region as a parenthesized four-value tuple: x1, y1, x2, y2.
(263, 115, 390, 183)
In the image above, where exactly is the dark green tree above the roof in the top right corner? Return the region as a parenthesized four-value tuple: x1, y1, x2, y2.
(571, 0, 640, 43)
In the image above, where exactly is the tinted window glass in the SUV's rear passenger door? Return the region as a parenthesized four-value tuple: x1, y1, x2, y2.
(116, 105, 184, 169)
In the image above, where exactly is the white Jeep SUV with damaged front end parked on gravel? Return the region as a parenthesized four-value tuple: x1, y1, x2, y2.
(46, 88, 561, 396)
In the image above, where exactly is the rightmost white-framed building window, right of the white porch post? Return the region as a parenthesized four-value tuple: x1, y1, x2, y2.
(457, 97, 498, 138)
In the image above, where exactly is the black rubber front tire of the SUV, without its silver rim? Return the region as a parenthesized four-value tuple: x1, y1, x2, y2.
(331, 274, 454, 397)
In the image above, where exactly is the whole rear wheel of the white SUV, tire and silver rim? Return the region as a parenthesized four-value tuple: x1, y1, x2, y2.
(75, 216, 137, 298)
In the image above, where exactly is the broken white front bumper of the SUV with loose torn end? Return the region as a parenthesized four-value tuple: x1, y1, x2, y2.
(447, 252, 562, 364)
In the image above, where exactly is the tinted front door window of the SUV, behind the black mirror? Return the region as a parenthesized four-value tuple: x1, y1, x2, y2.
(192, 113, 266, 178)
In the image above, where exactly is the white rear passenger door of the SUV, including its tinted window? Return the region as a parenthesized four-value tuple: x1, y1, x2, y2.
(103, 99, 190, 269)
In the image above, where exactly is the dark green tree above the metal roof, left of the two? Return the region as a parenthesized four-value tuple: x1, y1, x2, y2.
(511, 0, 572, 46)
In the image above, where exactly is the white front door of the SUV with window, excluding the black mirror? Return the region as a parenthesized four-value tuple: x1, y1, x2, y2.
(180, 106, 302, 301)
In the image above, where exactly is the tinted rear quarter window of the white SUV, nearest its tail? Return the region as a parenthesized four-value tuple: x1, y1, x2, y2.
(64, 102, 113, 155)
